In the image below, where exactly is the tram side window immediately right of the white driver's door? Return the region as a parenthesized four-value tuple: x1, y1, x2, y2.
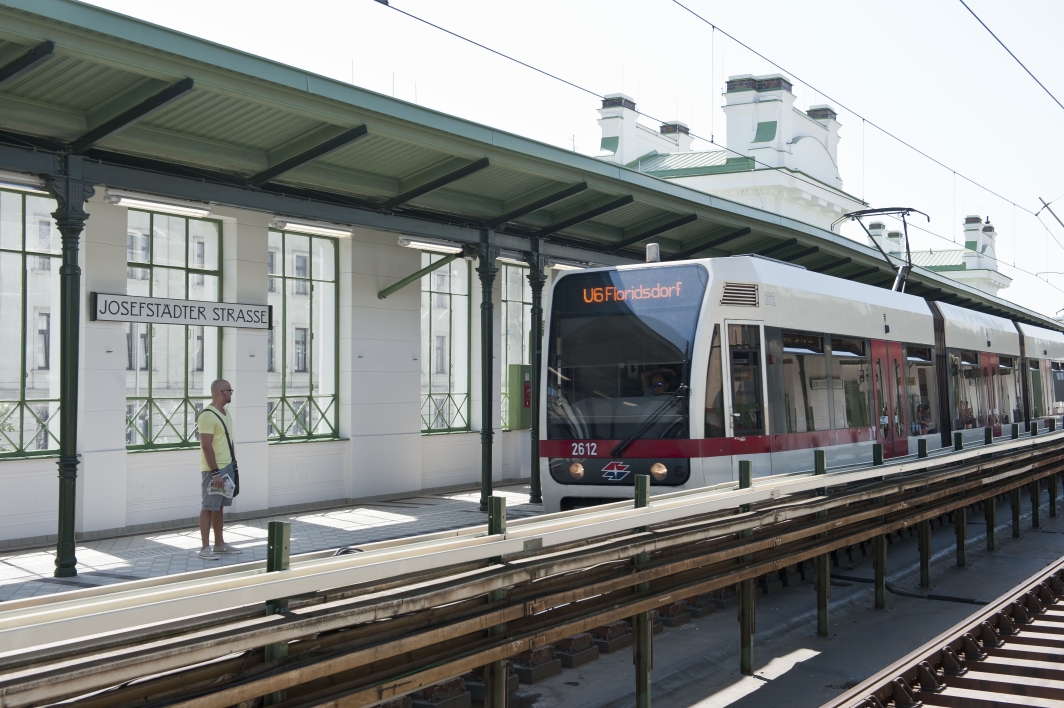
(783, 332, 831, 432)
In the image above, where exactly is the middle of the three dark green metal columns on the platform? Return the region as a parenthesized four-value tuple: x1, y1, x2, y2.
(477, 234, 499, 511)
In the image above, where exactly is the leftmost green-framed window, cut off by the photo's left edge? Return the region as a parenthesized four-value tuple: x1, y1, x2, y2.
(0, 190, 62, 458)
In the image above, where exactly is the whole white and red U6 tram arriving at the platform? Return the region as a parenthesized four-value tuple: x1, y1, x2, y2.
(539, 256, 1064, 511)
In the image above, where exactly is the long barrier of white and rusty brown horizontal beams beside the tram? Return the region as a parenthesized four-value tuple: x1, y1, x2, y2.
(0, 433, 1064, 708)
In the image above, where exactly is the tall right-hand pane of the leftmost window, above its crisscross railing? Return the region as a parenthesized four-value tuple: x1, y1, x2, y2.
(24, 256, 60, 398)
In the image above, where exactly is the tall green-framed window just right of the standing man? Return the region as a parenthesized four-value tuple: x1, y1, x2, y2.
(266, 229, 339, 443)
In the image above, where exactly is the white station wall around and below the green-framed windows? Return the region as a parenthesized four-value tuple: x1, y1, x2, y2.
(0, 190, 549, 547)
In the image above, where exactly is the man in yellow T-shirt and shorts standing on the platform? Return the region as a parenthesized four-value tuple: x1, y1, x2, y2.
(198, 379, 240, 560)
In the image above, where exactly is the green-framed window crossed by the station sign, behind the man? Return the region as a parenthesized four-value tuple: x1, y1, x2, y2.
(126, 209, 222, 450)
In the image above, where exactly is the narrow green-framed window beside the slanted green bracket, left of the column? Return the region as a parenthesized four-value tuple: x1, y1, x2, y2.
(421, 251, 471, 433)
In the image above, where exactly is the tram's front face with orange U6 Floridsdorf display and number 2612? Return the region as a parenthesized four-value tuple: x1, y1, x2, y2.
(541, 263, 709, 511)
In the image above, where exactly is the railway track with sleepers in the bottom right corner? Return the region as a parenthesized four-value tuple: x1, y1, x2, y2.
(822, 545, 1064, 708)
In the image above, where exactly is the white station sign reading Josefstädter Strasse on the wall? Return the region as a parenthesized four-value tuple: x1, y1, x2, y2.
(89, 293, 273, 329)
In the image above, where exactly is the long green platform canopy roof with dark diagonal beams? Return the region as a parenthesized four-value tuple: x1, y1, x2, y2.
(0, 0, 1062, 330)
